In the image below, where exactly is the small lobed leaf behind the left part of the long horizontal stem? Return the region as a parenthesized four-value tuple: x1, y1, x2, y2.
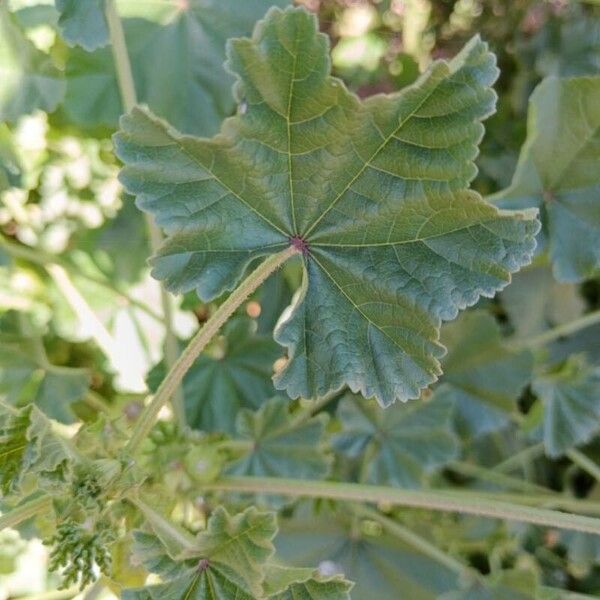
(227, 398, 330, 504)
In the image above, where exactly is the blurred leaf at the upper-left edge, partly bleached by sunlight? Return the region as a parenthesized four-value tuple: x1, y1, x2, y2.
(0, 3, 64, 121)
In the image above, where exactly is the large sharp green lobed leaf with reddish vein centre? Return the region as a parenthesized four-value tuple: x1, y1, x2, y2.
(114, 9, 538, 406)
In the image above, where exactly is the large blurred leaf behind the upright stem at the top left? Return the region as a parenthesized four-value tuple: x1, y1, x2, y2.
(63, 0, 289, 135)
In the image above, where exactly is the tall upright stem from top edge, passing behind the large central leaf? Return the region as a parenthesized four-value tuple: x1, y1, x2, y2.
(105, 0, 186, 429)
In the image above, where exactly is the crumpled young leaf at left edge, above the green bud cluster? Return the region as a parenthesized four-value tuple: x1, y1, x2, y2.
(0, 402, 73, 495)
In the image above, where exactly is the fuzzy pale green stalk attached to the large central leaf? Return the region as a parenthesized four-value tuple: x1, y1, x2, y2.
(126, 246, 297, 454)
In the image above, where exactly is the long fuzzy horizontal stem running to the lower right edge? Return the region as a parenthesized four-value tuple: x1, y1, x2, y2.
(204, 477, 600, 534)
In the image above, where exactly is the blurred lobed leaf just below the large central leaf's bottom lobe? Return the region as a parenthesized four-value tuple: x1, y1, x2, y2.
(333, 394, 458, 488)
